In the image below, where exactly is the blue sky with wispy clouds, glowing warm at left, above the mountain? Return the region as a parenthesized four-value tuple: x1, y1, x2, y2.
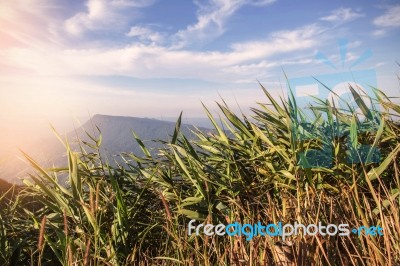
(0, 0, 400, 147)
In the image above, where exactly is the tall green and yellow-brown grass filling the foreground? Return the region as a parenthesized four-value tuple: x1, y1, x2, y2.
(0, 84, 400, 265)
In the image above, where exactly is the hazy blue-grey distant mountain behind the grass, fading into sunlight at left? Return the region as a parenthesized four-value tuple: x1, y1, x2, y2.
(0, 115, 210, 183)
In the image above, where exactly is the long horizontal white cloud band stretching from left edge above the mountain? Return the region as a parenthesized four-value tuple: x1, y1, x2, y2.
(2, 25, 323, 82)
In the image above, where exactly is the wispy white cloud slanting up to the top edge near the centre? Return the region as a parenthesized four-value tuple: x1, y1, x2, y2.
(175, 0, 275, 47)
